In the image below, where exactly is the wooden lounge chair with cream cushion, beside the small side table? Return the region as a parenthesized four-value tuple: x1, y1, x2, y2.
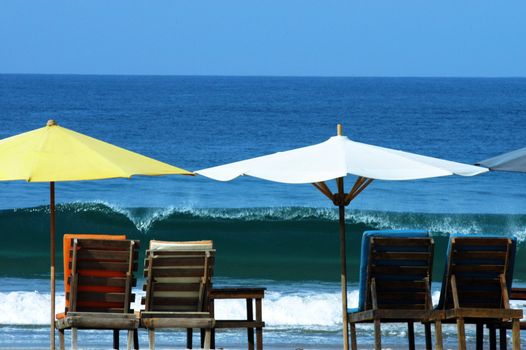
(141, 241, 215, 349)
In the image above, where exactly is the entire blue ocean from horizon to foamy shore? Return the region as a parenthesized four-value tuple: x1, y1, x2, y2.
(0, 75, 526, 349)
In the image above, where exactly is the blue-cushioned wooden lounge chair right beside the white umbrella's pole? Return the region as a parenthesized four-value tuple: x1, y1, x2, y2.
(348, 230, 434, 350)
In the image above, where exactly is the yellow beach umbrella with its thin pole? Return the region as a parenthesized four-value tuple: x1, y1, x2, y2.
(0, 120, 193, 349)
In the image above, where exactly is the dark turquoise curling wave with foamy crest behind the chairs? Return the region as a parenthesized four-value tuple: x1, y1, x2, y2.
(0, 203, 526, 282)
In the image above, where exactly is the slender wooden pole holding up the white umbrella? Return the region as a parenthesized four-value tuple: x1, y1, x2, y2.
(336, 178, 349, 350)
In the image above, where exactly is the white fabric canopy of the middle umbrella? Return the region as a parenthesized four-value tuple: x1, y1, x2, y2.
(196, 136, 488, 184)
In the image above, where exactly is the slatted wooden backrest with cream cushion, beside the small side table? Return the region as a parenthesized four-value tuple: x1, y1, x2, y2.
(142, 241, 215, 312)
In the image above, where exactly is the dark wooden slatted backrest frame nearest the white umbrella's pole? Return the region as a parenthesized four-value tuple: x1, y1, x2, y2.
(365, 236, 434, 310)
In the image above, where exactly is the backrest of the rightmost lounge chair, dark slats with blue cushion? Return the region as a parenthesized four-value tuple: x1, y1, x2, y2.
(437, 235, 516, 309)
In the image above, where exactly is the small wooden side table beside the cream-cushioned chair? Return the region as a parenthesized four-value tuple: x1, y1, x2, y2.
(209, 287, 266, 350)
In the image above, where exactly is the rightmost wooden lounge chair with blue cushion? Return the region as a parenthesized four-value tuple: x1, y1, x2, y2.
(432, 235, 522, 350)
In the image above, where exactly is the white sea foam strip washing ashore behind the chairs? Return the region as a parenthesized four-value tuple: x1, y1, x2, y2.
(0, 284, 526, 341)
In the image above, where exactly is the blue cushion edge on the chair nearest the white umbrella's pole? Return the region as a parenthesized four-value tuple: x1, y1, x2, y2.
(358, 230, 429, 311)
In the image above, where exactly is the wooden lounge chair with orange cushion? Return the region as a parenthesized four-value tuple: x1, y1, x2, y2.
(55, 238, 139, 349)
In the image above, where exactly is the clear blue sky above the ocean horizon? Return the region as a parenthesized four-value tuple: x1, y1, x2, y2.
(0, 0, 526, 77)
